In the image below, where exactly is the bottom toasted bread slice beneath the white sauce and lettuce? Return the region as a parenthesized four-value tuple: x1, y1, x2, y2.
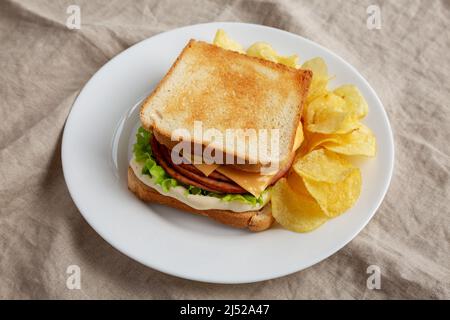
(128, 167, 274, 232)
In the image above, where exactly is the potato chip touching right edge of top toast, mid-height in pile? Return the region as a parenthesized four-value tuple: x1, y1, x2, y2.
(305, 93, 358, 134)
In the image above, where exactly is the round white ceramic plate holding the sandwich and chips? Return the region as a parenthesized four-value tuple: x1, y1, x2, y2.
(62, 23, 394, 283)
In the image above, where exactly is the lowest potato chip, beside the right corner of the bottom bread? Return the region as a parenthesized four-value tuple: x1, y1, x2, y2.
(271, 178, 328, 232)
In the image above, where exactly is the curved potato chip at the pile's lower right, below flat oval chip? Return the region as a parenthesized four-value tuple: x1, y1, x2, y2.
(303, 168, 361, 218)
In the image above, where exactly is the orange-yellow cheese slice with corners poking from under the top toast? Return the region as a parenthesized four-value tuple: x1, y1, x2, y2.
(195, 122, 304, 197)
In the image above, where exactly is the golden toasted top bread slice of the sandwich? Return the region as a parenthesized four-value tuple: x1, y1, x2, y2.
(141, 40, 312, 171)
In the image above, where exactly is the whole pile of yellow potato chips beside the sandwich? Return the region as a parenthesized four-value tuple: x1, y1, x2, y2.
(214, 30, 376, 232)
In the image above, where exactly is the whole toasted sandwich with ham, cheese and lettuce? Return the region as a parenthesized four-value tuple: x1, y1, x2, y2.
(128, 40, 312, 231)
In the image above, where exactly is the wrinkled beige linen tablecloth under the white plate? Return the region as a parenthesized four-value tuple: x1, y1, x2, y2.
(0, 0, 450, 299)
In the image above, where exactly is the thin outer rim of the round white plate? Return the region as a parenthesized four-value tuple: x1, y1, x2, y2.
(61, 21, 395, 284)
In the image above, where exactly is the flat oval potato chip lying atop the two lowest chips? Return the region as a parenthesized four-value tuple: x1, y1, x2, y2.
(293, 149, 354, 183)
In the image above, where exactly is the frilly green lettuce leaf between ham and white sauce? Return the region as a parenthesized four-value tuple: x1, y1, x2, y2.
(133, 127, 267, 206)
